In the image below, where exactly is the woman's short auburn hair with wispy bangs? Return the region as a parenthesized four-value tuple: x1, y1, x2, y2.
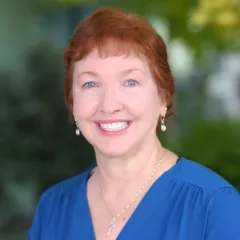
(64, 7, 174, 131)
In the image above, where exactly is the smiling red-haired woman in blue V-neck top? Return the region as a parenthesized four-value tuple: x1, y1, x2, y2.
(28, 8, 240, 240)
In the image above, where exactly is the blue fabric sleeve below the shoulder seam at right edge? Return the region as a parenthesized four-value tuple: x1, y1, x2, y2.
(203, 187, 240, 240)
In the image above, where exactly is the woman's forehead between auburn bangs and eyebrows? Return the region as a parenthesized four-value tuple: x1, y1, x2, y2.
(75, 50, 150, 75)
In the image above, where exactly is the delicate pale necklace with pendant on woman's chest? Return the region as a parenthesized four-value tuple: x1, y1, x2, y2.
(102, 153, 163, 236)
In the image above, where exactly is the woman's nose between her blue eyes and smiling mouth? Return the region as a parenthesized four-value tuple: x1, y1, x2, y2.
(99, 87, 123, 114)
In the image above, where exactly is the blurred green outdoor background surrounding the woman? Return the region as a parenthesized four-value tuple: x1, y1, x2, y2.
(0, 0, 240, 240)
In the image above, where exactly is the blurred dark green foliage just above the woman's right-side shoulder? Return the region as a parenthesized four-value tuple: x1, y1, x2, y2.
(172, 119, 240, 190)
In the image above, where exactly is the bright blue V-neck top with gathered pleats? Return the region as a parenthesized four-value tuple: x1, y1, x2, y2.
(28, 157, 240, 240)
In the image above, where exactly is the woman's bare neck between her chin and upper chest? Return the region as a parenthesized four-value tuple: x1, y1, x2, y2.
(96, 136, 163, 196)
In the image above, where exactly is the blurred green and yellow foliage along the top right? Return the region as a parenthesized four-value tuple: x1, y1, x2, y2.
(39, 0, 240, 58)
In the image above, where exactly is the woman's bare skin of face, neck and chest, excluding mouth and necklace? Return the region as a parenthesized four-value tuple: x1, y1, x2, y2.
(73, 50, 177, 239)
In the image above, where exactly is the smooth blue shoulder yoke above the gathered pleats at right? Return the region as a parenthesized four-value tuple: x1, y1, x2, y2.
(175, 157, 234, 194)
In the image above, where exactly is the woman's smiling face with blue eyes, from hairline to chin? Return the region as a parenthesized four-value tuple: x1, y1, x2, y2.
(73, 51, 165, 157)
